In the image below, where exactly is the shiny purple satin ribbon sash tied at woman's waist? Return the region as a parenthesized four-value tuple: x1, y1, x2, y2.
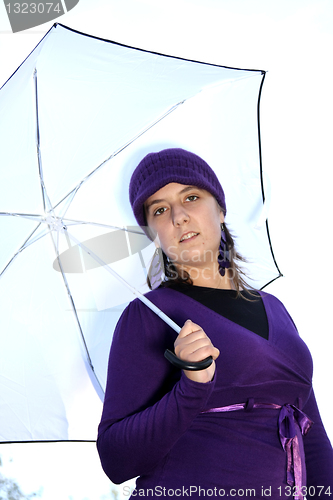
(201, 398, 313, 500)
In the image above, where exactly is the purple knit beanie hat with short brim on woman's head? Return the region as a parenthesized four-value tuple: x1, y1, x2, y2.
(129, 148, 227, 226)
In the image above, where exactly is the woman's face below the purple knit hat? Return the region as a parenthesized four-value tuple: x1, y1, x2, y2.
(145, 182, 224, 270)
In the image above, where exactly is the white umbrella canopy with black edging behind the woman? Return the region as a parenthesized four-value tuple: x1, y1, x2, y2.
(0, 24, 280, 442)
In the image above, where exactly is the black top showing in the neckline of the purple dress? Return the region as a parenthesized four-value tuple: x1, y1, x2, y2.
(172, 284, 268, 340)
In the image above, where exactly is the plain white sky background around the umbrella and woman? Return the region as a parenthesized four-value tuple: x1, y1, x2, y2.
(0, 0, 333, 500)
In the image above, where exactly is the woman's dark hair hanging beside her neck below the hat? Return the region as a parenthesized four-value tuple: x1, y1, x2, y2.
(147, 223, 253, 300)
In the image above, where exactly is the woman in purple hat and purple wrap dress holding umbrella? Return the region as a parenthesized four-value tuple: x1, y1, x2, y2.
(97, 149, 333, 499)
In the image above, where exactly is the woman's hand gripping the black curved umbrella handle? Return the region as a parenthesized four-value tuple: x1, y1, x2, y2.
(175, 319, 220, 383)
